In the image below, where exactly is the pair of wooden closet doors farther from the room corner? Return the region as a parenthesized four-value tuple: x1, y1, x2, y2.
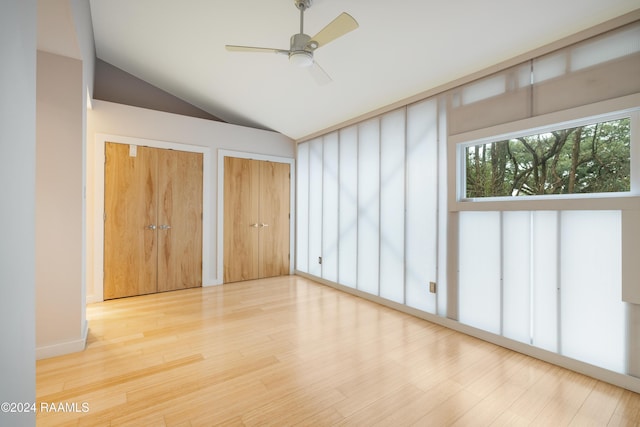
(103, 142, 202, 299)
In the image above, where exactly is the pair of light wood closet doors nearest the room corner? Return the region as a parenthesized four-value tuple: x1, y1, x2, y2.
(224, 157, 291, 283)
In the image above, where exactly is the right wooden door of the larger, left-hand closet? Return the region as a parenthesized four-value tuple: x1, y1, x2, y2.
(158, 150, 202, 292)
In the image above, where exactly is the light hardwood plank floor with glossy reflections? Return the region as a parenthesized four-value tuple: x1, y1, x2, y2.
(37, 276, 640, 427)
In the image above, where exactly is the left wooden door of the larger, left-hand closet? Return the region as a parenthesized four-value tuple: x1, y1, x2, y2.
(104, 143, 158, 299)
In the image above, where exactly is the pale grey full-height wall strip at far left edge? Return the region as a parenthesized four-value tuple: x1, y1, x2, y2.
(0, 0, 36, 426)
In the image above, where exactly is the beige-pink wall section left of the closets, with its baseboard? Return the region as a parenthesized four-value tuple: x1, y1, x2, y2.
(28, 0, 95, 358)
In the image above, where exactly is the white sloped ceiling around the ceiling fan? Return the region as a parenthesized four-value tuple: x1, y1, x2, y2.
(90, 0, 639, 139)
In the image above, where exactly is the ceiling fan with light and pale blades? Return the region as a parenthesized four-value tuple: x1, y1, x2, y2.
(226, 0, 358, 84)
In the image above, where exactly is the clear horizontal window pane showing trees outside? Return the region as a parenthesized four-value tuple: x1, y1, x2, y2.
(465, 118, 631, 198)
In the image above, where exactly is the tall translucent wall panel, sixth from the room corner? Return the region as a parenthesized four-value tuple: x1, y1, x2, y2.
(380, 109, 405, 303)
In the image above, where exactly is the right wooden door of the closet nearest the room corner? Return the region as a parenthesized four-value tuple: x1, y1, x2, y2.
(258, 162, 290, 278)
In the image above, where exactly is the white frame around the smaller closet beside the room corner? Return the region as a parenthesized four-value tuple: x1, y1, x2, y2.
(216, 149, 296, 285)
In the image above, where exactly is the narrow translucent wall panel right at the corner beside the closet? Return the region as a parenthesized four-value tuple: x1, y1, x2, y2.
(296, 143, 309, 273)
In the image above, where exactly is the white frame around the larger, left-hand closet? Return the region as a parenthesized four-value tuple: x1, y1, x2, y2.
(93, 134, 212, 303)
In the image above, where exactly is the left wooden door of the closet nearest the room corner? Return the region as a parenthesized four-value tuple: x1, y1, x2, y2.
(224, 157, 260, 283)
